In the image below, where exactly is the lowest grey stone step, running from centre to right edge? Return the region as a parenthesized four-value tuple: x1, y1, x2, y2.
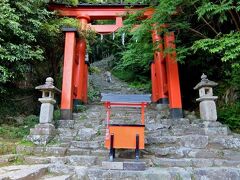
(86, 167, 240, 180)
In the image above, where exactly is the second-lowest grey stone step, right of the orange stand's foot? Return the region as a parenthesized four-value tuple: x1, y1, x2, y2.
(152, 157, 240, 168)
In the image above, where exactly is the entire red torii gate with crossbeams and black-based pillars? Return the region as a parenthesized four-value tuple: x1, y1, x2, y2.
(49, 3, 182, 119)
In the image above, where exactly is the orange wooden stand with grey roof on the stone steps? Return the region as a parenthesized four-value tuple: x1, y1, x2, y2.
(101, 94, 151, 161)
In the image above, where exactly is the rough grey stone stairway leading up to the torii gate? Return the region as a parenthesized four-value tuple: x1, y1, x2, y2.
(0, 57, 240, 180)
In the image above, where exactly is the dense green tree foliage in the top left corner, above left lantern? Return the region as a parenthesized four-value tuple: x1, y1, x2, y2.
(0, 0, 52, 91)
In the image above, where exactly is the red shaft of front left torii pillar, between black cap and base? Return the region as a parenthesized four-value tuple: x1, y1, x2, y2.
(61, 32, 76, 110)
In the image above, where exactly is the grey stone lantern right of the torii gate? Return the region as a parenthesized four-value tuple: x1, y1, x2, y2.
(194, 74, 218, 121)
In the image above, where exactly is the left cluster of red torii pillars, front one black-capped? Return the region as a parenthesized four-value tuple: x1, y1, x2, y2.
(61, 16, 90, 120)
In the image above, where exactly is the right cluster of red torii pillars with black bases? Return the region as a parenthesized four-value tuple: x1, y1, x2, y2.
(151, 28, 183, 119)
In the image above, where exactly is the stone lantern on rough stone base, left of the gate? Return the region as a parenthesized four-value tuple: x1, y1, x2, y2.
(27, 77, 61, 145)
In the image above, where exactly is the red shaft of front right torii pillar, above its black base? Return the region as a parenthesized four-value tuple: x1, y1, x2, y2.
(164, 32, 182, 108)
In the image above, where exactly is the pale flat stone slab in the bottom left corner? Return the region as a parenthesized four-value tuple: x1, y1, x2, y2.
(0, 164, 49, 180)
